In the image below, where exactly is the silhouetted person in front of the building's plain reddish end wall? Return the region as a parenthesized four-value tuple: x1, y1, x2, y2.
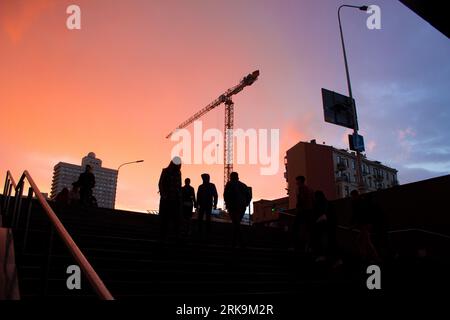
(293, 176, 313, 253)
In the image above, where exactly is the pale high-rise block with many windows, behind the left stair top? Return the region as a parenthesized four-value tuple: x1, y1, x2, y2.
(51, 152, 117, 208)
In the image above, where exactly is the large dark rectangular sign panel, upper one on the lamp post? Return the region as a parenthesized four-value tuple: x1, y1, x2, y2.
(322, 88, 358, 129)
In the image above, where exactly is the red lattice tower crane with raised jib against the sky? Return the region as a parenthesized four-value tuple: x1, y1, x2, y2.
(166, 70, 259, 186)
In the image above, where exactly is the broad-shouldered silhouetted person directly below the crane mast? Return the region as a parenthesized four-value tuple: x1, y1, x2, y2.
(223, 172, 252, 247)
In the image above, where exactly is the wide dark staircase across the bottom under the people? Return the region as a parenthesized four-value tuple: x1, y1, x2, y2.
(8, 204, 450, 301)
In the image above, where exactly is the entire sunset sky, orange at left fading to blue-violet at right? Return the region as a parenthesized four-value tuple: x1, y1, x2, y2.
(0, 0, 450, 211)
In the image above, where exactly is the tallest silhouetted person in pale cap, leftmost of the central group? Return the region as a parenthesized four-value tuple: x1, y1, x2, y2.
(158, 157, 181, 241)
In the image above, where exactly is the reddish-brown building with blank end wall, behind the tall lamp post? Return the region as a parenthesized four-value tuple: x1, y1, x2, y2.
(284, 140, 398, 208)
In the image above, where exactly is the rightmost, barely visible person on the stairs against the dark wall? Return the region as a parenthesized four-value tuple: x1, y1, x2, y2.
(350, 190, 379, 262)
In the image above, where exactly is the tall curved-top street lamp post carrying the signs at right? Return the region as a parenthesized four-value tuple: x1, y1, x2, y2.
(338, 4, 369, 191)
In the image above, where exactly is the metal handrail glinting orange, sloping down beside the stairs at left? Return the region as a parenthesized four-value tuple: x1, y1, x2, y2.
(5, 170, 114, 300)
